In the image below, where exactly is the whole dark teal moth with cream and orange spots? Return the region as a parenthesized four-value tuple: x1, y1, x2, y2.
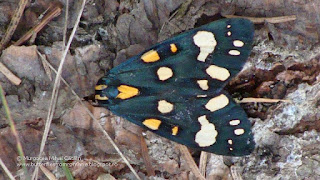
(95, 19, 254, 156)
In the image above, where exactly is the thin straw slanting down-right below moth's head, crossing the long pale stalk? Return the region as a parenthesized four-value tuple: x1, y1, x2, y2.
(38, 52, 140, 179)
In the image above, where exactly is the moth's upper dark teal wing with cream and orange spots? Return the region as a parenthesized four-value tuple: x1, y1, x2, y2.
(109, 19, 254, 96)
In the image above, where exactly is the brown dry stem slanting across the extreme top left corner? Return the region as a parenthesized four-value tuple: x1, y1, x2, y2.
(0, 0, 28, 51)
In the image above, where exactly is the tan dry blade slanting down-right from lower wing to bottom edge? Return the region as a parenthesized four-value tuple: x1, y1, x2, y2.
(178, 144, 205, 180)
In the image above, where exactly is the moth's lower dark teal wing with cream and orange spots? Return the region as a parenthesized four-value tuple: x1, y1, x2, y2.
(109, 92, 254, 156)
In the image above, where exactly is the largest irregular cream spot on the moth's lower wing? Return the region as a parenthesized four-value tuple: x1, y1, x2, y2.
(195, 115, 218, 147)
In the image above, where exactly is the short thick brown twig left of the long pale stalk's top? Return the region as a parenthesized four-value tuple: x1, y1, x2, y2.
(14, 6, 62, 46)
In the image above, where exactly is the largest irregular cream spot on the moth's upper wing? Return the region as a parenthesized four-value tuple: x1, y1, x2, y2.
(193, 31, 217, 62)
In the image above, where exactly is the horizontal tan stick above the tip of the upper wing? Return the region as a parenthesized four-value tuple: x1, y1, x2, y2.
(224, 15, 297, 24)
